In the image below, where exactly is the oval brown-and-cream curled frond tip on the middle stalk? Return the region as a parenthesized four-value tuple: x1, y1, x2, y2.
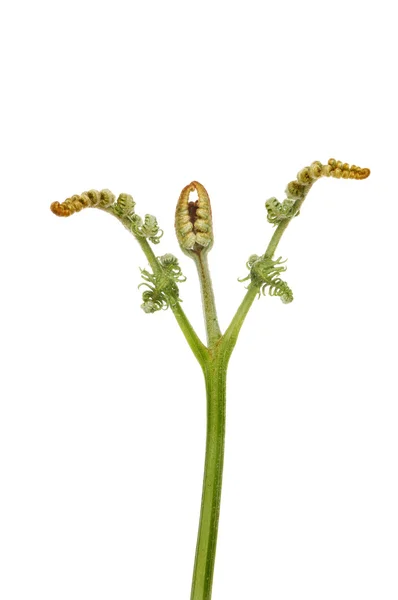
(175, 181, 213, 256)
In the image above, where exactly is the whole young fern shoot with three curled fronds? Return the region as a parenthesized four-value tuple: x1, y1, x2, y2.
(51, 159, 370, 600)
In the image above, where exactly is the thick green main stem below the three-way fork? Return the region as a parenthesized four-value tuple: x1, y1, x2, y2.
(191, 345, 228, 600)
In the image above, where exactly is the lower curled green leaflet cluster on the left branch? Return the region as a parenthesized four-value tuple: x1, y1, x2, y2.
(138, 254, 186, 313)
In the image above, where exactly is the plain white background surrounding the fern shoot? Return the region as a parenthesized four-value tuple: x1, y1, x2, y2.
(0, 0, 398, 600)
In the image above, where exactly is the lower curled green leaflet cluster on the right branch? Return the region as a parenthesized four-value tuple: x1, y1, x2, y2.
(239, 254, 293, 304)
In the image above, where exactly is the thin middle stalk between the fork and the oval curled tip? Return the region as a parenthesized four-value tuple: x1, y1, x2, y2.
(192, 252, 221, 348)
